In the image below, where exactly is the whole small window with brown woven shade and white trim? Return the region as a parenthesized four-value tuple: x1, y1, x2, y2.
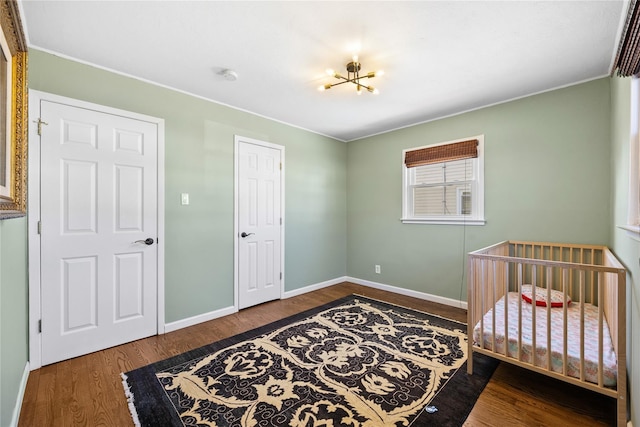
(402, 136, 485, 225)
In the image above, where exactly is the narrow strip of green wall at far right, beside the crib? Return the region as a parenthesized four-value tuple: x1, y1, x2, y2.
(610, 78, 640, 425)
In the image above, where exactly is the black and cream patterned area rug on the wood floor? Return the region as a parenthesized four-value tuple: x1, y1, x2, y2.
(123, 296, 495, 427)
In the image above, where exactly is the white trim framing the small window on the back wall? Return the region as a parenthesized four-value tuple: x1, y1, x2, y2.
(400, 135, 486, 225)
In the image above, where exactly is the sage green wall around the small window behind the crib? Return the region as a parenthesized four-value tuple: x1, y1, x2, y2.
(347, 78, 610, 300)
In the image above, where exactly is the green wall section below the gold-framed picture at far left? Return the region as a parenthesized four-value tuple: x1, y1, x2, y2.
(0, 218, 29, 426)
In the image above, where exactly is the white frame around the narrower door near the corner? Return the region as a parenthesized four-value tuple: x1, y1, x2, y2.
(233, 135, 285, 312)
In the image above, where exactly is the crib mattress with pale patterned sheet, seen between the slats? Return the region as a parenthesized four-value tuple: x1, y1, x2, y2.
(473, 292, 618, 386)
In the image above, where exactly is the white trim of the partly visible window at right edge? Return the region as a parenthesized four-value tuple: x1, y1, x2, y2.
(618, 77, 640, 241)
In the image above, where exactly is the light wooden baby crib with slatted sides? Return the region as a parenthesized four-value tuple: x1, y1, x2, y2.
(467, 241, 627, 427)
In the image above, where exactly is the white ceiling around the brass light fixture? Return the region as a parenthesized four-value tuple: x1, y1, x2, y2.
(21, 0, 628, 141)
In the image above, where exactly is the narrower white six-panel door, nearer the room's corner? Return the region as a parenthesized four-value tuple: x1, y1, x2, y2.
(236, 137, 283, 309)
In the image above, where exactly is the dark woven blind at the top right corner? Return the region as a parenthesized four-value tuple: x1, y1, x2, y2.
(611, 0, 640, 77)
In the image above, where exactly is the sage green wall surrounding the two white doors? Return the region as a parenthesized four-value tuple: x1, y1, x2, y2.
(29, 50, 347, 322)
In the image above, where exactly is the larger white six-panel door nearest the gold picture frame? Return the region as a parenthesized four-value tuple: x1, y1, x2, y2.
(40, 100, 158, 365)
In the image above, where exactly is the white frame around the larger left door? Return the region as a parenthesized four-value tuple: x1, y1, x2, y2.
(27, 89, 165, 371)
